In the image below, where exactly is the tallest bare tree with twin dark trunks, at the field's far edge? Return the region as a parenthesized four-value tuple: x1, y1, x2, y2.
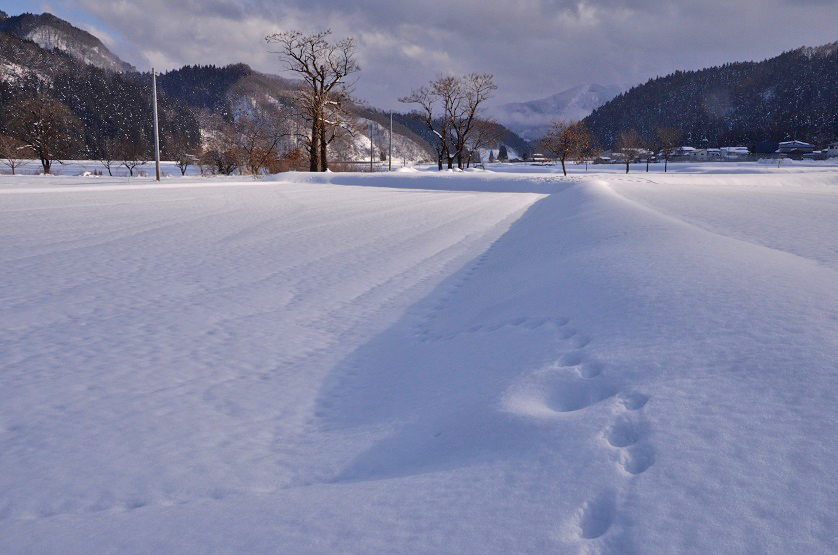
(266, 30, 360, 171)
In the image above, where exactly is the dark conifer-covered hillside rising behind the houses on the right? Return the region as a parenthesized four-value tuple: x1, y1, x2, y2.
(584, 43, 838, 152)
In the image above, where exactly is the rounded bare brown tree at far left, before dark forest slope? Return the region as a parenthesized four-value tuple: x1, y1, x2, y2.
(5, 93, 80, 173)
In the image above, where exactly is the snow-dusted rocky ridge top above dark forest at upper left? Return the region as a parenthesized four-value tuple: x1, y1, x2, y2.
(0, 13, 134, 73)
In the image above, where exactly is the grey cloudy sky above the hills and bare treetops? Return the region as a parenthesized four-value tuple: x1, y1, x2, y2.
(8, 0, 838, 109)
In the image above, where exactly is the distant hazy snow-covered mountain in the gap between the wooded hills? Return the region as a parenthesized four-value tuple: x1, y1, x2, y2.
(487, 85, 623, 140)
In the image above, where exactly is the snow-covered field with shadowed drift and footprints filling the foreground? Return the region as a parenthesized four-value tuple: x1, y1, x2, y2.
(0, 164, 838, 553)
